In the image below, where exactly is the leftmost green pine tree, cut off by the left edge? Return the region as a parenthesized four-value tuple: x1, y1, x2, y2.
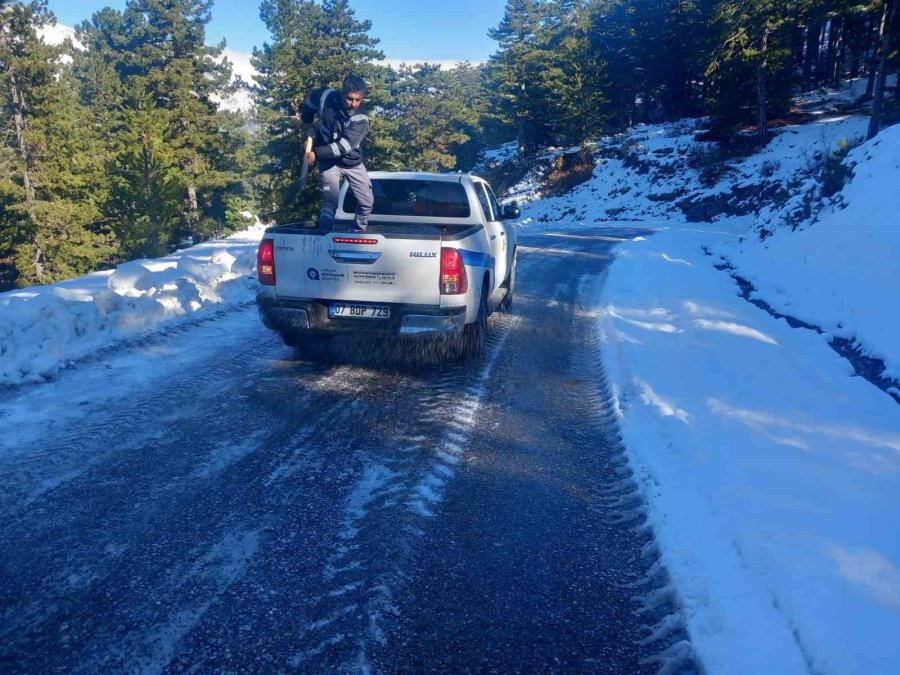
(0, 2, 115, 285)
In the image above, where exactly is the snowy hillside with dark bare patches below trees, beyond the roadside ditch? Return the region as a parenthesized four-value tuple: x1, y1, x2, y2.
(510, 77, 900, 388)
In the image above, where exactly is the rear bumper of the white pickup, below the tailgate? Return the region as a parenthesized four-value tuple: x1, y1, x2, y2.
(256, 293, 466, 338)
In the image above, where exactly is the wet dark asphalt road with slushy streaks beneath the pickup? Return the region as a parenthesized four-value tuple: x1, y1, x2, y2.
(0, 230, 695, 673)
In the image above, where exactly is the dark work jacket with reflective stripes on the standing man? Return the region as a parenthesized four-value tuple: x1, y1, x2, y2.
(300, 87, 369, 169)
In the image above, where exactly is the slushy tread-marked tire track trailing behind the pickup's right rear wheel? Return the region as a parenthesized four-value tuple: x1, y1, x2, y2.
(288, 316, 515, 672)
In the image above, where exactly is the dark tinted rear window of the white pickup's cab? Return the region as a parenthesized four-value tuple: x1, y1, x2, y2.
(343, 179, 470, 218)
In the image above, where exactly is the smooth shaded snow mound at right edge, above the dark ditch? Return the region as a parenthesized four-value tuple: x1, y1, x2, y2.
(717, 125, 900, 379)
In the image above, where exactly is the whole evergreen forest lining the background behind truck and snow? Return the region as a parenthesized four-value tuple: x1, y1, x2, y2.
(0, 0, 900, 291)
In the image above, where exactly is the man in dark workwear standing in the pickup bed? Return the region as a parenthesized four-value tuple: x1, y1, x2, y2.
(300, 75, 374, 232)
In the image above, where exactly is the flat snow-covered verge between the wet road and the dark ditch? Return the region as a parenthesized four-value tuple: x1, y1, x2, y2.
(600, 230, 900, 674)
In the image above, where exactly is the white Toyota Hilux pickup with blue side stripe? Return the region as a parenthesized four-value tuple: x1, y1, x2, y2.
(256, 172, 519, 356)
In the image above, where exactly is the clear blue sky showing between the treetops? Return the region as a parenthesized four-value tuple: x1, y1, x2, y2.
(49, 0, 506, 61)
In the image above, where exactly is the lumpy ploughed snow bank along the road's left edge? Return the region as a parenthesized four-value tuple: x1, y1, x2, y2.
(0, 225, 265, 385)
